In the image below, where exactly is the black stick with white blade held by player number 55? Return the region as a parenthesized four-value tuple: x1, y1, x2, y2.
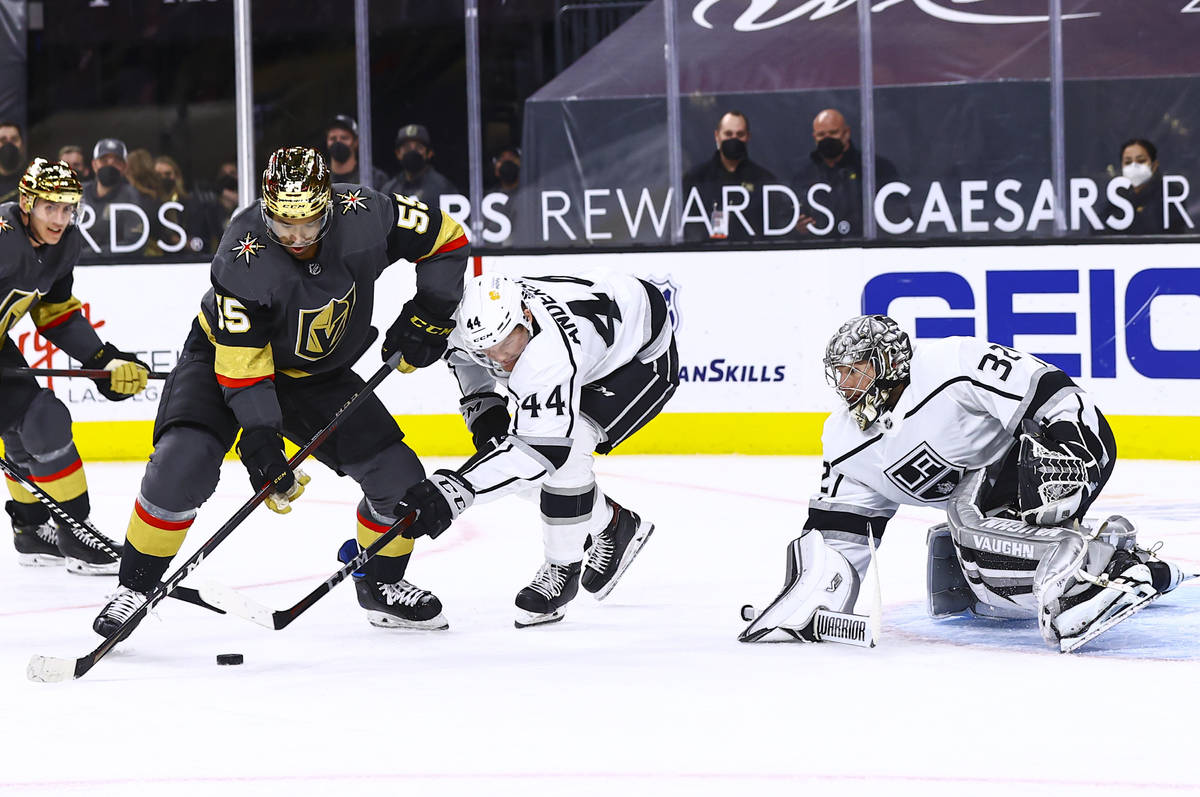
(25, 353, 403, 683)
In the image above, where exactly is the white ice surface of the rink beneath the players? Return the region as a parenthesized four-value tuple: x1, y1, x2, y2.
(0, 456, 1200, 797)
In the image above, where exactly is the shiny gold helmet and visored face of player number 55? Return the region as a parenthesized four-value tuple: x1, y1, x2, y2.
(259, 146, 334, 247)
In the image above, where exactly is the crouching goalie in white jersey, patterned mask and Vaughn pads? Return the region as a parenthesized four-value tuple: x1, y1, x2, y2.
(739, 316, 1186, 652)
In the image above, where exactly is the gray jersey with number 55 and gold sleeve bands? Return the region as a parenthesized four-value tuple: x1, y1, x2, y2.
(198, 184, 469, 426)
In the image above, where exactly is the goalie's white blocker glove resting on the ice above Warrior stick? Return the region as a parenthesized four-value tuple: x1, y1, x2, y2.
(738, 529, 859, 642)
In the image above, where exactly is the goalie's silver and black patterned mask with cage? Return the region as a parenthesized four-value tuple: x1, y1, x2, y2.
(824, 316, 912, 432)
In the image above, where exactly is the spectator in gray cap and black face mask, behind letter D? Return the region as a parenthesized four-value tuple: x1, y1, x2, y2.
(80, 138, 152, 257)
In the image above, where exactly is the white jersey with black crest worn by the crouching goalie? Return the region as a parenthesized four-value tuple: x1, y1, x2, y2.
(805, 337, 1108, 574)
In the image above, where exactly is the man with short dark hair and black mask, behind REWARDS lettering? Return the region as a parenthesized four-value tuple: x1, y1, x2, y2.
(683, 110, 776, 241)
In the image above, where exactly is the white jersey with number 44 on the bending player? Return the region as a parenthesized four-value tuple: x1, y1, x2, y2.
(446, 274, 672, 498)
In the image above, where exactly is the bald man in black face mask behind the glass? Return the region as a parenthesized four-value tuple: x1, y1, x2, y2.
(792, 108, 899, 238)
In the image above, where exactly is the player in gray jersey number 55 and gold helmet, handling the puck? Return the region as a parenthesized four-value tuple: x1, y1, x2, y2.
(94, 146, 468, 636)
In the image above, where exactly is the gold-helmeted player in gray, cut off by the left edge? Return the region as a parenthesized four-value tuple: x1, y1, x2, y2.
(0, 157, 150, 575)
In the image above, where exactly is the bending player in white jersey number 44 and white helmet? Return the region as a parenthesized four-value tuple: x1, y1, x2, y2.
(396, 274, 679, 628)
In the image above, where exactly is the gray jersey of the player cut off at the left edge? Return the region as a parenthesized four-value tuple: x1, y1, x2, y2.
(0, 202, 101, 360)
